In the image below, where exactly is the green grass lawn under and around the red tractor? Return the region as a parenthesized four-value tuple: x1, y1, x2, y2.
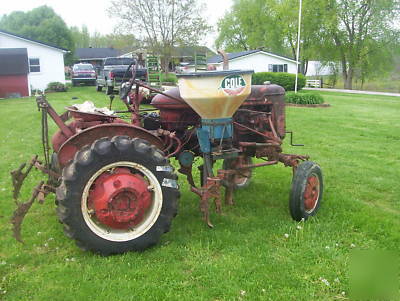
(0, 87, 400, 301)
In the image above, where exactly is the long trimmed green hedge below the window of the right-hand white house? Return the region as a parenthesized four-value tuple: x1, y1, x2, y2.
(252, 72, 306, 91)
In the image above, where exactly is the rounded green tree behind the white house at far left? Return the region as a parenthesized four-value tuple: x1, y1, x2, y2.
(0, 5, 75, 64)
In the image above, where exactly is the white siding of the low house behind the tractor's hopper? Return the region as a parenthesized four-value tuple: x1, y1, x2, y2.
(212, 53, 296, 74)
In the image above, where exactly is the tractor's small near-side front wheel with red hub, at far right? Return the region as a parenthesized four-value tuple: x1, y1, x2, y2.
(289, 161, 324, 221)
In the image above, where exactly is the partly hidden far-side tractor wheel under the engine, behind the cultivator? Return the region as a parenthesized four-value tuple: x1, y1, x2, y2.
(222, 156, 253, 189)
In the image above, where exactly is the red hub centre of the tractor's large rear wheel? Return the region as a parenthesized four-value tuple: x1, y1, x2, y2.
(88, 168, 152, 229)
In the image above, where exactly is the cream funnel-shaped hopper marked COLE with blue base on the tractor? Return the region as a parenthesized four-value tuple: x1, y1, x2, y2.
(178, 70, 254, 158)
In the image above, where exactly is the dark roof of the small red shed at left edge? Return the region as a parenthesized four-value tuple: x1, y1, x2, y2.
(0, 48, 29, 75)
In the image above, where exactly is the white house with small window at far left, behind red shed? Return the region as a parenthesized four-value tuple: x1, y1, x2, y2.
(0, 30, 68, 95)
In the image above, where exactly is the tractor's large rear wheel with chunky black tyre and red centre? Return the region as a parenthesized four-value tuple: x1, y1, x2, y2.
(57, 136, 179, 255)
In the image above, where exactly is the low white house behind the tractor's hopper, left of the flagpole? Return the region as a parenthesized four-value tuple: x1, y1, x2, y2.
(207, 50, 297, 74)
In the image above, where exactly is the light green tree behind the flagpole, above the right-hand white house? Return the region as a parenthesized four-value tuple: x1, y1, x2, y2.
(216, 0, 323, 73)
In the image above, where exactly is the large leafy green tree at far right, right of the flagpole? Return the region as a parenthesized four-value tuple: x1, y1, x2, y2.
(321, 0, 400, 89)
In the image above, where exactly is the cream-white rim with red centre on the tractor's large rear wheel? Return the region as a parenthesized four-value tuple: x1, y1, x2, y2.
(81, 161, 163, 241)
